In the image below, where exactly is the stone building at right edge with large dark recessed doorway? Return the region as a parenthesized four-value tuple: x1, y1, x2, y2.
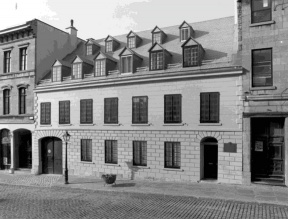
(237, 0, 288, 185)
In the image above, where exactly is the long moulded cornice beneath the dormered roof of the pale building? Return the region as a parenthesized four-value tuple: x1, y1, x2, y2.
(34, 66, 243, 93)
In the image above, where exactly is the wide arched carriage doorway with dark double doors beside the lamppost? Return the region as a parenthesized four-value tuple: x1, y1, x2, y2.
(41, 137, 63, 174)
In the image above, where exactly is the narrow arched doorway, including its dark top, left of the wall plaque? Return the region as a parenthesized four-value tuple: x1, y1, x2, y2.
(201, 138, 218, 180)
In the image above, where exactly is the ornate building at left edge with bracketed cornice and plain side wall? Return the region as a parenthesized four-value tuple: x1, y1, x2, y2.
(0, 20, 80, 173)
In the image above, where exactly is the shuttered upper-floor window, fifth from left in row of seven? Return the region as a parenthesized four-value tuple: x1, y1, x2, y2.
(132, 97, 148, 124)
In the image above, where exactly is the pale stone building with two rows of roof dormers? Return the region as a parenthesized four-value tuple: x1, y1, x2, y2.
(32, 17, 243, 184)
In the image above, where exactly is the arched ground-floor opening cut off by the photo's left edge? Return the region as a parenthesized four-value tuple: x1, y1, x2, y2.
(0, 129, 11, 170)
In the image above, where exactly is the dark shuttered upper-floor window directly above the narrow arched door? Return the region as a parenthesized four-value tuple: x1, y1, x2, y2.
(200, 92, 220, 123)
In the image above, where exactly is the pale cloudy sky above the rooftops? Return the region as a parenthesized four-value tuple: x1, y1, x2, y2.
(0, 0, 236, 40)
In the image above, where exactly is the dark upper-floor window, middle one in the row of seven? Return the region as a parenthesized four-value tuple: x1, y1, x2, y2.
(104, 98, 118, 124)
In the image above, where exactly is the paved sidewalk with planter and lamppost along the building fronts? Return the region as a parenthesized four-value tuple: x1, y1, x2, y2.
(0, 172, 288, 206)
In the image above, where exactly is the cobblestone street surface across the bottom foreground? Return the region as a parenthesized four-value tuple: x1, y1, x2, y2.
(0, 185, 288, 219)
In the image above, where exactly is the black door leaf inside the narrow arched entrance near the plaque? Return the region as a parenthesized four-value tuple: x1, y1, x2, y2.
(204, 145, 218, 179)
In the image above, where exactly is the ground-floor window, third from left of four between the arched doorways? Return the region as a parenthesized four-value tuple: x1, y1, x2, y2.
(133, 141, 147, 166)
